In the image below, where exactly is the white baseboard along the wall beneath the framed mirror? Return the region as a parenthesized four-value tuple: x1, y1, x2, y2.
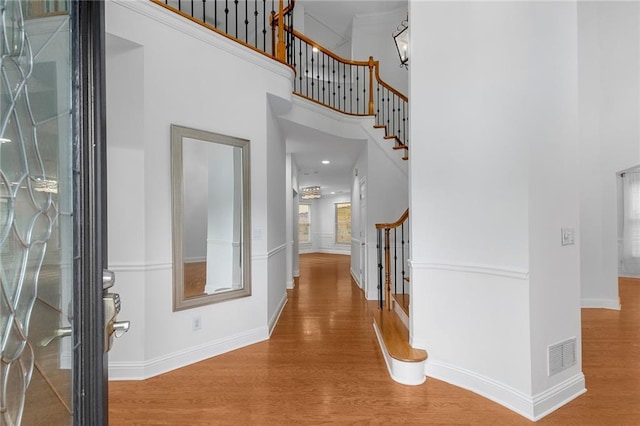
(109, 326, 269, 380)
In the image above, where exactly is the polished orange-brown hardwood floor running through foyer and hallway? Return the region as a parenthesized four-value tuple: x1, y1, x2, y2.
(109, 255, 640, 425)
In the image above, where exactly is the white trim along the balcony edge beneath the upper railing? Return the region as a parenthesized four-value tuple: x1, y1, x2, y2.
(106, 0, 292, 80)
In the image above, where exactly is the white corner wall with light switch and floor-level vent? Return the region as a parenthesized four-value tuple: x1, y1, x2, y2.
(410, 1, 584, 419)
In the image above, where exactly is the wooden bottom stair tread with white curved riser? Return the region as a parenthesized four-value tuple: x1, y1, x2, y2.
(369, 301, 427, 362)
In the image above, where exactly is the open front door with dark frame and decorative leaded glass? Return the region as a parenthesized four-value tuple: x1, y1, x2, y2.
(0, 0, 119, 425)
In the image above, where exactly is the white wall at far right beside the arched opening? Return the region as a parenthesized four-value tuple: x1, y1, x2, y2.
(578, 2, 640, 309)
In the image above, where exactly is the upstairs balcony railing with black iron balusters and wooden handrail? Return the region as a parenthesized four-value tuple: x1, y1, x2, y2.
(151, 0, 409, 160)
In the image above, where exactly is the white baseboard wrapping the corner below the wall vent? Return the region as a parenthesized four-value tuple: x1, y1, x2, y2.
(425, 359, 586, 421)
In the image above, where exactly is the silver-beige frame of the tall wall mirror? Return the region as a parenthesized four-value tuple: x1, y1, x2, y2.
(171, 124, 251, 311)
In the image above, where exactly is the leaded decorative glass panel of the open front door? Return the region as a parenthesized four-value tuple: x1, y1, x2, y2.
(0, 0, 74, 425)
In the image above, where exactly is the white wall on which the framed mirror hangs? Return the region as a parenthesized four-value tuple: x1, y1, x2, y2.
(106, 1, 292, 379)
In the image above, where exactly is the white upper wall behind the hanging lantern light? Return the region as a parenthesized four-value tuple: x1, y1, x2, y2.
(351, 8, 409, 95)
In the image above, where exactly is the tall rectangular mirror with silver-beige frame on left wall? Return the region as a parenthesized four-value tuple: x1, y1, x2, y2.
(171, 124, 251, 311)
